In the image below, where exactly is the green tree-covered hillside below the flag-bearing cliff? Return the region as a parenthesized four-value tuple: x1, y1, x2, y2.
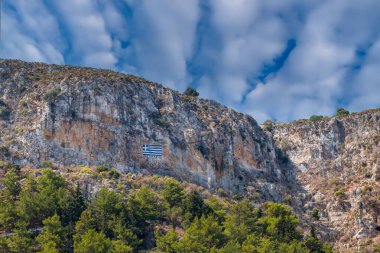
(0, 163, 332, 253)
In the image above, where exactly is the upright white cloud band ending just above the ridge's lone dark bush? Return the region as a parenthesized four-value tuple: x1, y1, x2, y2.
(124, 0, 200, 90)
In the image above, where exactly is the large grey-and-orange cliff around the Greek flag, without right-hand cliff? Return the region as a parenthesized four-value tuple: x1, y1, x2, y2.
(0, 61, 285, 199)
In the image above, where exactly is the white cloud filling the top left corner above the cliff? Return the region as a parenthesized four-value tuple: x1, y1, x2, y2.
(1, 0, 64, 63)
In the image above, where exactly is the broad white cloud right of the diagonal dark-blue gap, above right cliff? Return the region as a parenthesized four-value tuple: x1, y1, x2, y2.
(243, 0, 380, 121)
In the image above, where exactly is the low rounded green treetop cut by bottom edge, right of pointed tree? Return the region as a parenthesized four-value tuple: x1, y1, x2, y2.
(74, 229, 113, 253)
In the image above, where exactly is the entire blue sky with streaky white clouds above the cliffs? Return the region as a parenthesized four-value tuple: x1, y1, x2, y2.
(0, 0, 380, 122)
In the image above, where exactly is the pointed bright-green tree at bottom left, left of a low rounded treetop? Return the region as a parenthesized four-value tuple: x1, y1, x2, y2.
(36, 214, 66, 253)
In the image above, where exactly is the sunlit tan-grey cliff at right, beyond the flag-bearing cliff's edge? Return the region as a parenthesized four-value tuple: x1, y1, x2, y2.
(271, 110, 380, 252)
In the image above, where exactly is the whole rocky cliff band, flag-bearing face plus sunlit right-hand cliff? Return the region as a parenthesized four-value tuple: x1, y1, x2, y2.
(0, 60, 380, 252)
